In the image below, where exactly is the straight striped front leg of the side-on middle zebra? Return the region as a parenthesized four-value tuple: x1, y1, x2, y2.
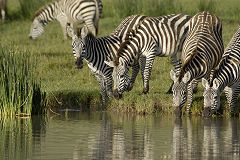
(143, 56, 155, 94)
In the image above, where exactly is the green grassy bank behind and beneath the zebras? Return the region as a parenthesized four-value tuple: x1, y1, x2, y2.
(0, 0, 240, 114)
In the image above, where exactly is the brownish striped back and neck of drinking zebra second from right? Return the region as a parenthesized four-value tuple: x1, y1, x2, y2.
(179, 12, 224, 81)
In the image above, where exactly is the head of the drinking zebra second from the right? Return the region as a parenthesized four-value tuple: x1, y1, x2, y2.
(170, 70, 191, 117)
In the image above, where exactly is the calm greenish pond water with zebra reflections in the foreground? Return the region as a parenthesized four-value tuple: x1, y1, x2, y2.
(0, 112, 240, 160)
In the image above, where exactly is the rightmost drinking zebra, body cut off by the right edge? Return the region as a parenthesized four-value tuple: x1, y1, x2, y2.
(202, 27, 240, 116)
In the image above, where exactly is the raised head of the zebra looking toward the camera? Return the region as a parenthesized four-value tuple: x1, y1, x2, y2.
(66, 25, 85, 69)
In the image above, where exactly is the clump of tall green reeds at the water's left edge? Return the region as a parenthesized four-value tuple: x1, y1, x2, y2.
(0, 46, 46, 116)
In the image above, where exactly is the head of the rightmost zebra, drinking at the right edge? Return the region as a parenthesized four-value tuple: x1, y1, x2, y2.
(202, 78, 220, 117)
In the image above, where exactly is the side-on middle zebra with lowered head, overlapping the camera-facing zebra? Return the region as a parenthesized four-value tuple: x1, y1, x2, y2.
(105, 14, 190, 97)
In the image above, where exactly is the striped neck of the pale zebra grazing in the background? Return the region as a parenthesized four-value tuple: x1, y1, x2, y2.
(35, 1, 59, 23)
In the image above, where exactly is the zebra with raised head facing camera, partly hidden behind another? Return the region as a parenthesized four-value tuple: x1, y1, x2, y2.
(67, 15, 146, 103)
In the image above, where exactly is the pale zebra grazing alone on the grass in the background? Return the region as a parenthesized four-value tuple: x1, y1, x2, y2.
(29, 0, 102, 39)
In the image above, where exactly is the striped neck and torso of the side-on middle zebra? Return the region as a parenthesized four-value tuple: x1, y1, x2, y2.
(115, 14, 190, 64)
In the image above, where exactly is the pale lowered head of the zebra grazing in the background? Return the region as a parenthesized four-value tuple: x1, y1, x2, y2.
(28, 18, 47, 39)
